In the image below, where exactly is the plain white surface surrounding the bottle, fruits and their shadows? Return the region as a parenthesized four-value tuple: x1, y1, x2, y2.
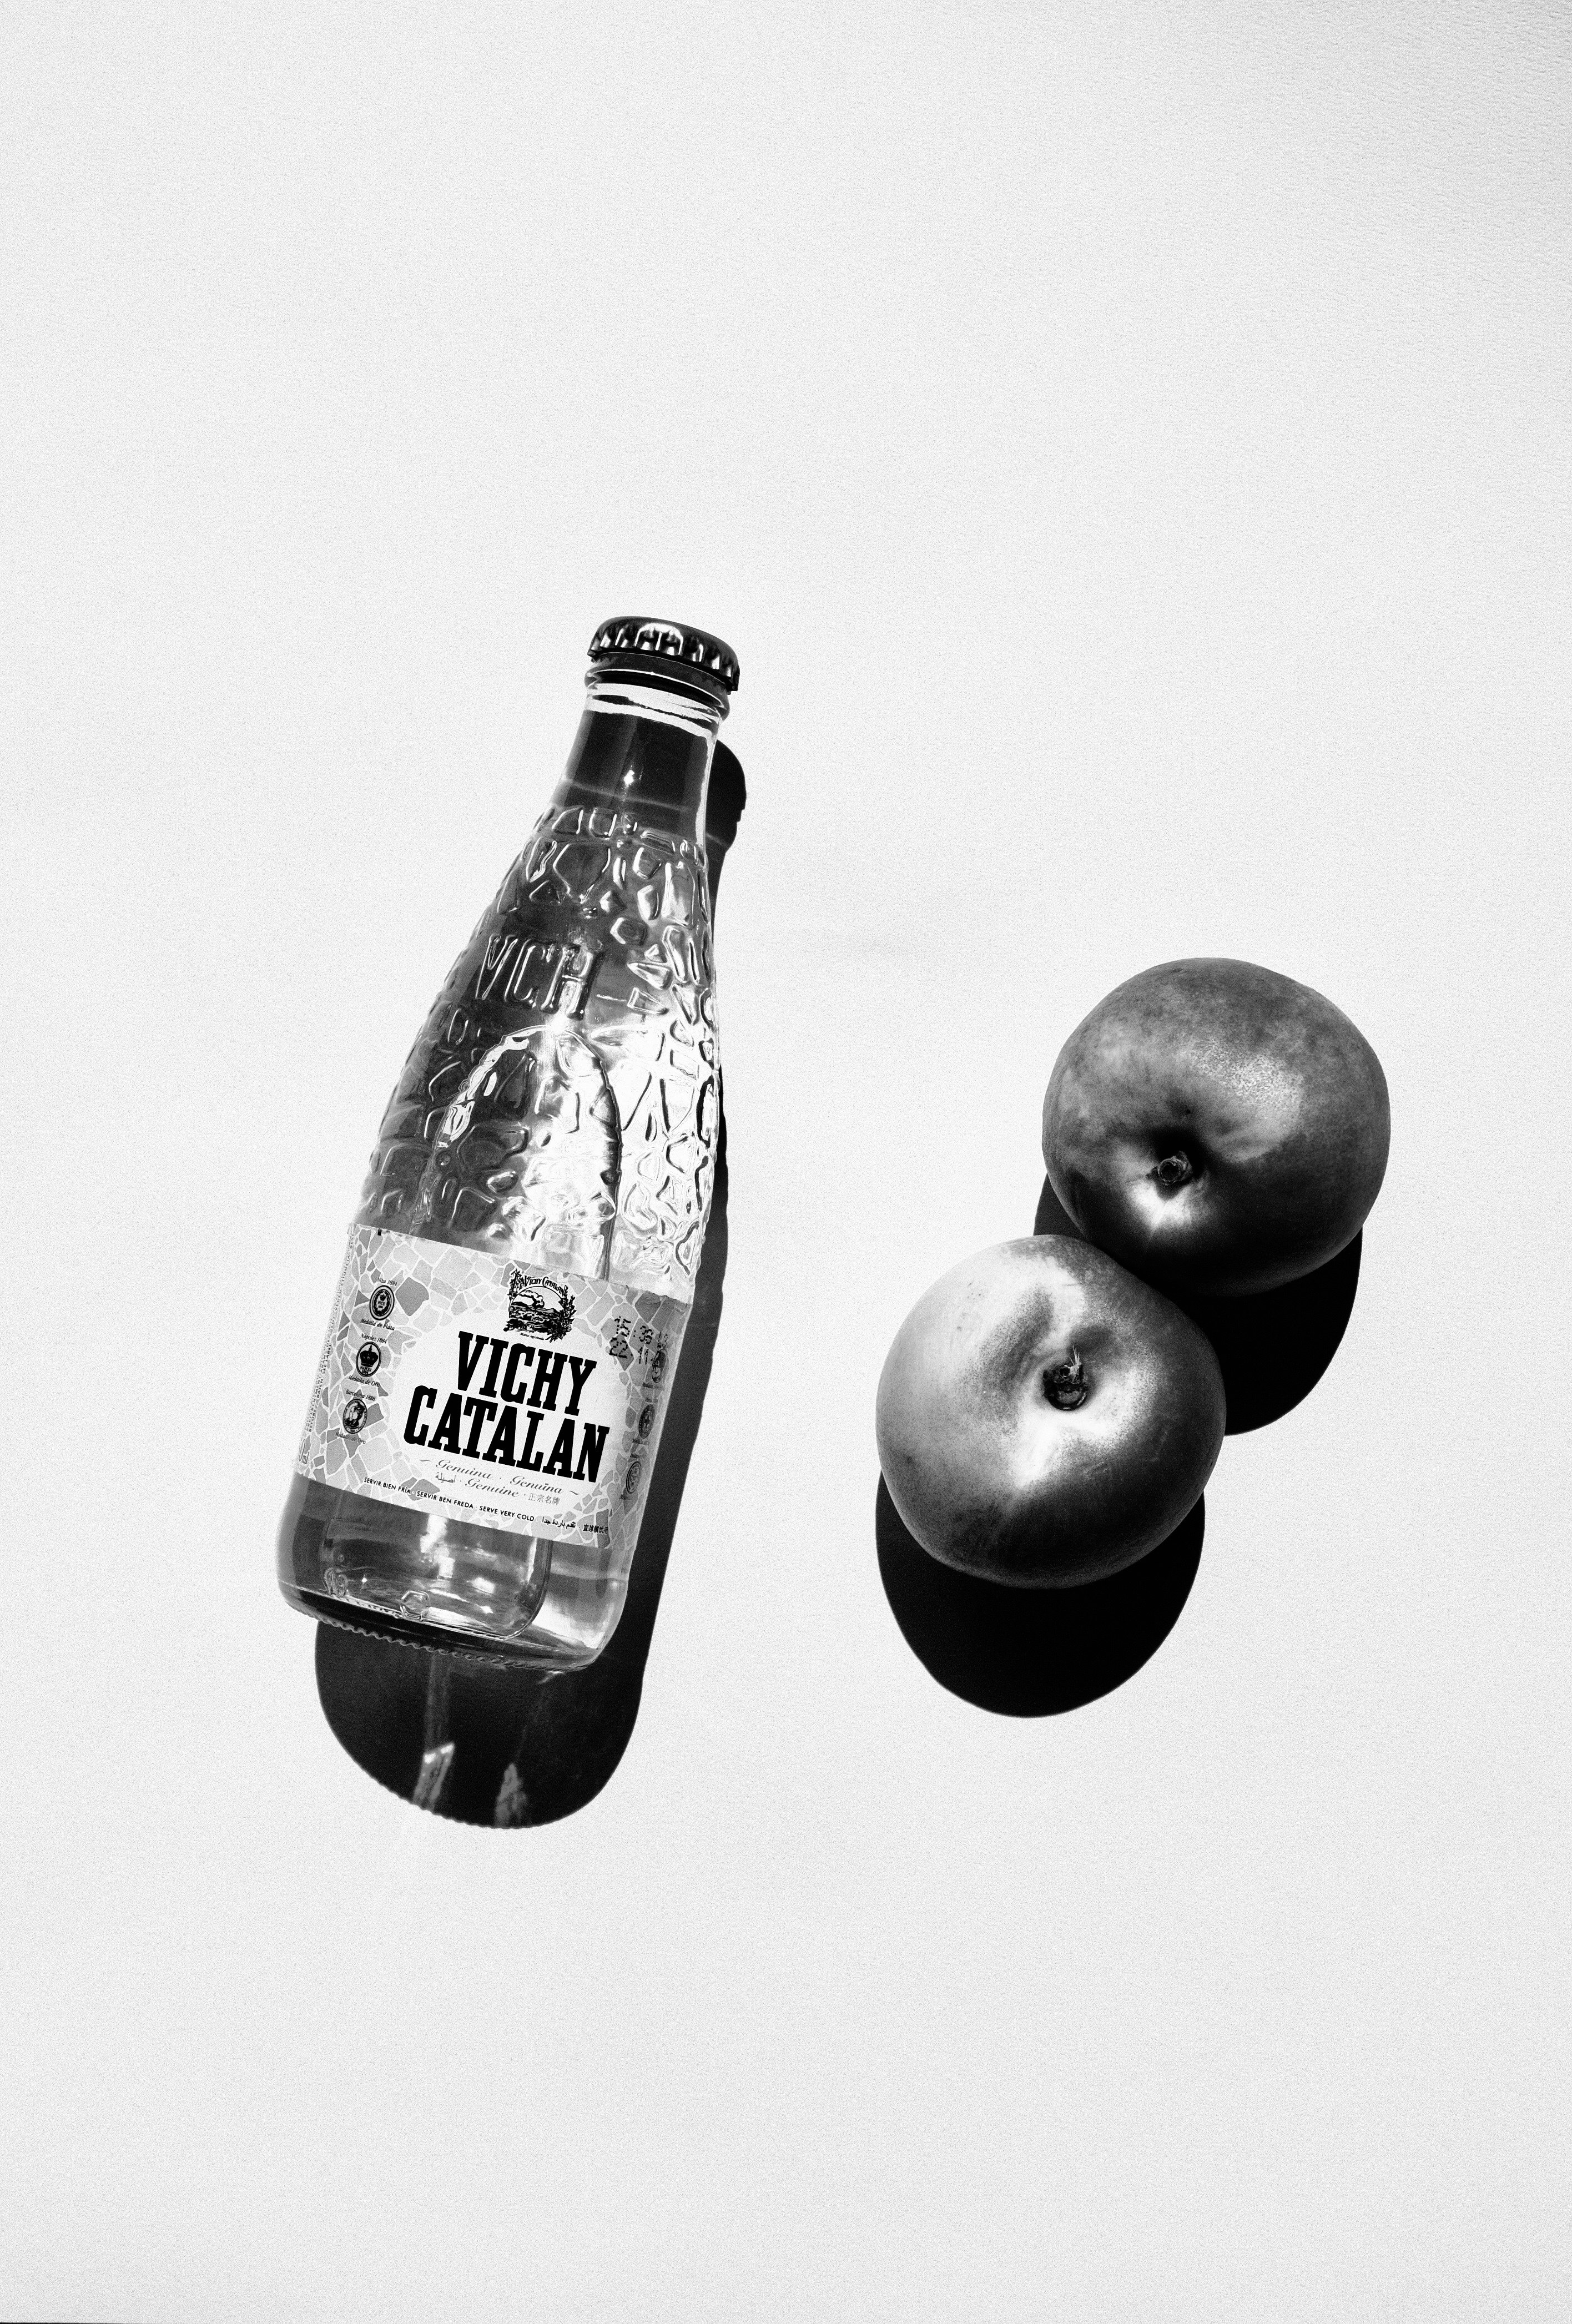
(0, 0, 1572, 2324)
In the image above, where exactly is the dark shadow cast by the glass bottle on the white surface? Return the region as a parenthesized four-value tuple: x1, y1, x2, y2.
(316, 744, 747, 1829)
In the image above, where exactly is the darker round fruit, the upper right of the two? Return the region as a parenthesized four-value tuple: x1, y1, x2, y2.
(1042, 960, 1390, 1297)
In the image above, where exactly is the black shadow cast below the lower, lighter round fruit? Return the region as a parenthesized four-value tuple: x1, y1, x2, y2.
(874, 1478, 1207, 1720)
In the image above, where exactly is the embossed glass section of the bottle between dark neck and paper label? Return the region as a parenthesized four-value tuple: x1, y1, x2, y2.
(360, 804, 719, 1297)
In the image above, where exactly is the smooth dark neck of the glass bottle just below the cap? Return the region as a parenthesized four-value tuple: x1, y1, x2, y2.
(553, 672, 725, 850)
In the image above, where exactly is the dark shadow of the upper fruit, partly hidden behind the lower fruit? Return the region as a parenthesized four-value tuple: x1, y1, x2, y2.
(1032, 1178, 1365, 1436)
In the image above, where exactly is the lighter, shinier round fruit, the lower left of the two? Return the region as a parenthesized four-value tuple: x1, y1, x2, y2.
(876, 1234, 1226, 1590)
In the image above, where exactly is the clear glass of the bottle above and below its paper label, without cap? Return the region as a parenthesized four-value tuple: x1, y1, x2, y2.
(279, 672, 723, 1666)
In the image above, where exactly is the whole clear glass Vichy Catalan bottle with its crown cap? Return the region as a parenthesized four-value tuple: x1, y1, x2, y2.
(279, 618, 737, 1668)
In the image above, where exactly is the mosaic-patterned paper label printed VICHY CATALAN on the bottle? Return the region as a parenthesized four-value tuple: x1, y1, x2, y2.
(295, 1227, 688, 1545)
